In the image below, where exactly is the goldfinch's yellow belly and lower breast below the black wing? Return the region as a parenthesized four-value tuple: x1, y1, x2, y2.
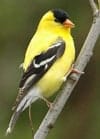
(36, 39, 75, 97)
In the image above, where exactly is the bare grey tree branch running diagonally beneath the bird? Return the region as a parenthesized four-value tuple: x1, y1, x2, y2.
(33, 0, 100, 139)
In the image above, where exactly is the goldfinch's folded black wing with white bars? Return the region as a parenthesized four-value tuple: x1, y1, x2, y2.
(19, 39, 65, 90)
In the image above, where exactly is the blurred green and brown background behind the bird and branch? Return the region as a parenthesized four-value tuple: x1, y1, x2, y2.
(0, 0, 100, 139)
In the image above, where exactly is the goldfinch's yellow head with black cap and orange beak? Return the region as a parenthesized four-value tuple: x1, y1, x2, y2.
(39, 9, 75, 29)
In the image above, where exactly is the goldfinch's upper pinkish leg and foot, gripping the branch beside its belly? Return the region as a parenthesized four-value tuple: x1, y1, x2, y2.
(63, 64, 84, 82)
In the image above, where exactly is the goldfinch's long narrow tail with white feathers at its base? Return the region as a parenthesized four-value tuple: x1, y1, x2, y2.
(6, 89, 39, 135)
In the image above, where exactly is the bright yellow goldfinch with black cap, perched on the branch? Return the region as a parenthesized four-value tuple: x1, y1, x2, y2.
(7, 9, 75, 133)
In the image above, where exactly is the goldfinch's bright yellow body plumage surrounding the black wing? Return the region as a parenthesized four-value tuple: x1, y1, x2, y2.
(23, 11, 75, 97)
